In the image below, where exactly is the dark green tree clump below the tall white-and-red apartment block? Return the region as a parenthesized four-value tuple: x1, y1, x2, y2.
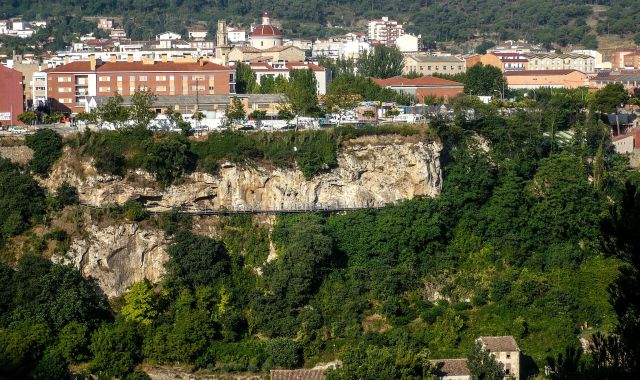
(357, 45, 404, 79)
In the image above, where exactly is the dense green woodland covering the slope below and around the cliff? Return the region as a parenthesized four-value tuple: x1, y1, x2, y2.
(0, 83, 640, 379)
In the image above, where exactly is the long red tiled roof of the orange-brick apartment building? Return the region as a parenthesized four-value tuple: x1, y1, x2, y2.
(45, 61, 233, 73)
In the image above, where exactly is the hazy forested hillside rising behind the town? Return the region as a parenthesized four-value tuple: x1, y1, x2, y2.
(0, 0, 640, 48)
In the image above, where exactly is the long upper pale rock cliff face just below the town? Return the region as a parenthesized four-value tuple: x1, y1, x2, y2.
(43, 136, 442, 210)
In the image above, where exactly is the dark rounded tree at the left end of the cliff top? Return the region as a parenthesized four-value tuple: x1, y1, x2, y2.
(26, 129, 63, 177)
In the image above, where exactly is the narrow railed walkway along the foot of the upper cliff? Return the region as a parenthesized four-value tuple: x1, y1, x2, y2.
(80, 202, 391, 216)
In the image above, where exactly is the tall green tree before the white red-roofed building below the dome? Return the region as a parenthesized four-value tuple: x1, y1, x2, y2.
(284, 69, 318, 115)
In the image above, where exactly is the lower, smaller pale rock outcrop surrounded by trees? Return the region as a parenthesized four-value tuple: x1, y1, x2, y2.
(52, 223, 169, 298)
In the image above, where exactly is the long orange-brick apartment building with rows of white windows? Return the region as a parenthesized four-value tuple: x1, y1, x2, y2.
(45, 58, 235, 113)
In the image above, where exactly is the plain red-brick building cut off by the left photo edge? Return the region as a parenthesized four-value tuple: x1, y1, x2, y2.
(0, 65, 24, 126)
